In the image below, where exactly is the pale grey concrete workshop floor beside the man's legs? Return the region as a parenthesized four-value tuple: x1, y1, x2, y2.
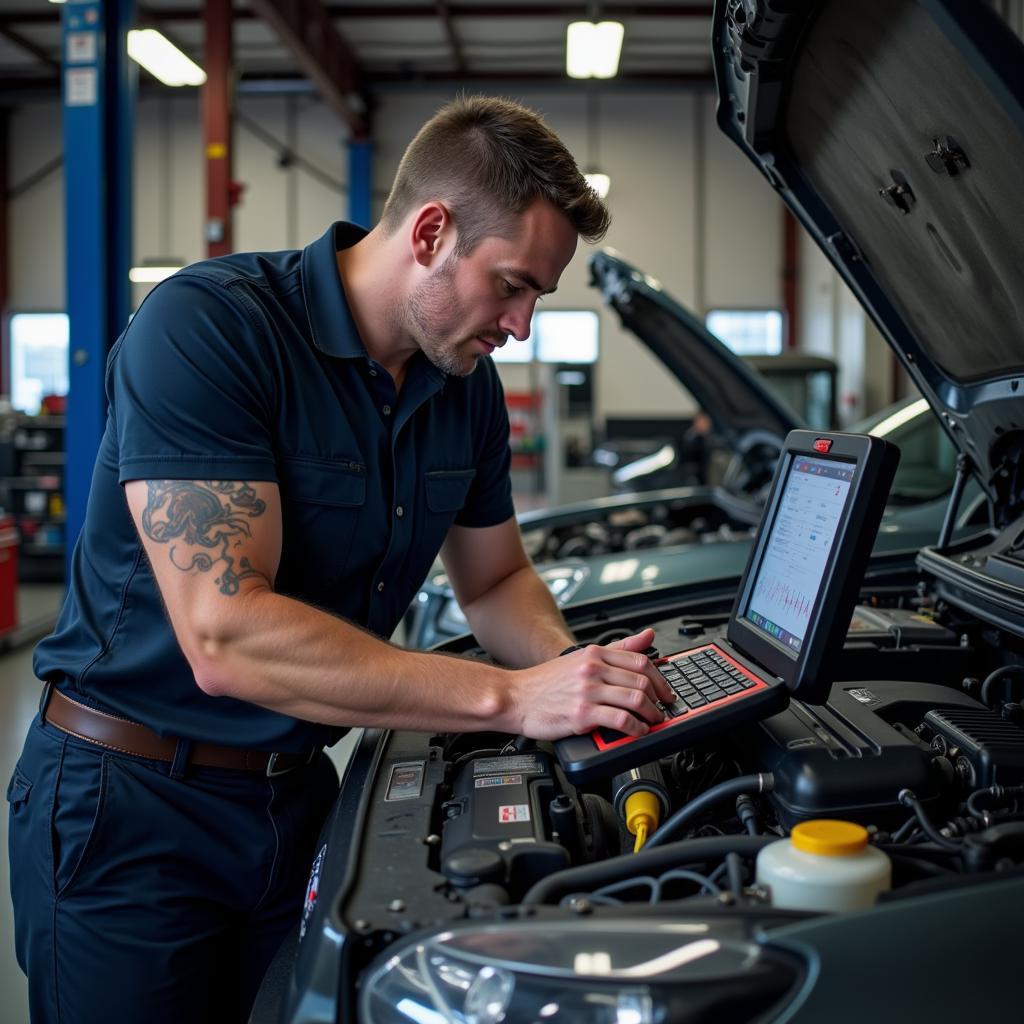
(0, 584, 362, 1024)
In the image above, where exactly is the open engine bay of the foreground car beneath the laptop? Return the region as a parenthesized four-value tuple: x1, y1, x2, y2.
(339, 584, 1024, 987)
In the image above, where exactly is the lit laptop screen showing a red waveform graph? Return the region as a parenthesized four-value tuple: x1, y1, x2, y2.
(746, 457, 853, 651)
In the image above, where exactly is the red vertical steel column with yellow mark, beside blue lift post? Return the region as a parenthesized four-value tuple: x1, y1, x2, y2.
(203, 0, 234, 256)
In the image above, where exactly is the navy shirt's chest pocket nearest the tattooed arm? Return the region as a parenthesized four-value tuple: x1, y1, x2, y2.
(276, 457, 367, 597)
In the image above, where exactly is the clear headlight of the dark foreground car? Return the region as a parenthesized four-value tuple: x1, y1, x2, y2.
(359, 920, 800, 1024)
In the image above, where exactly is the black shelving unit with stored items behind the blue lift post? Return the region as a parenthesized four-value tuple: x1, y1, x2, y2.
(0, 416, 66, 583)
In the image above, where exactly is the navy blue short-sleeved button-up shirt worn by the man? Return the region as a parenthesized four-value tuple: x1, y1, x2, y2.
(35, 223, 513, 751)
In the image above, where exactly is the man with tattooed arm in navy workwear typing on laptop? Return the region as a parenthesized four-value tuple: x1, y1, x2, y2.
(8, 97, 671, 1024)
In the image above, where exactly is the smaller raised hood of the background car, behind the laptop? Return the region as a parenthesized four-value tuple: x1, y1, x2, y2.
(590, 249, 805, 451)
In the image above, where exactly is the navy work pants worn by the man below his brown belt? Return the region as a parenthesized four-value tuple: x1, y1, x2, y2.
(6, 718, 338, 1024)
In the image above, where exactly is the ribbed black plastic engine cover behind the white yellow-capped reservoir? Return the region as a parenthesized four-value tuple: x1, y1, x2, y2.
(740, 680, 984, 828)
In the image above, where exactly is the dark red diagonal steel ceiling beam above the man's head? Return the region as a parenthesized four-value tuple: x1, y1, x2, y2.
(250, 0, 370, 138)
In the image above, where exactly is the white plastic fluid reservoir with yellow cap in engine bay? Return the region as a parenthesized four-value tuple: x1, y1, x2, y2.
(757, 818, 892, 911)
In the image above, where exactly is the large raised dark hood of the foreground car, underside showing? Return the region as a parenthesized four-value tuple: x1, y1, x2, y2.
(713, 0, 1024, 522)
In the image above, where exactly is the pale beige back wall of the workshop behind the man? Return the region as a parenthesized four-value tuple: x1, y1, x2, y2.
(10, 89, 802, 420)
